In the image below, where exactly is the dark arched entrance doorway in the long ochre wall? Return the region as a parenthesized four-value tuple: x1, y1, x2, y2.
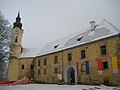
(67, 67, 75, 84)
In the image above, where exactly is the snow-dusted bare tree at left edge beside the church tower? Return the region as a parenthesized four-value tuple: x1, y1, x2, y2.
(0, 12, 11, 81)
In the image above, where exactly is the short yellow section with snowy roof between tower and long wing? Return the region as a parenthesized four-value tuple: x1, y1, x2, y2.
(18, 48, 38, 80)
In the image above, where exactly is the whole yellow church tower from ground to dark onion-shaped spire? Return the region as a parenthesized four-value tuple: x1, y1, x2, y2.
(8, 12, 23, 81)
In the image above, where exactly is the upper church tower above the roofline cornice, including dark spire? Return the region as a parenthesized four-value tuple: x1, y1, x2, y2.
(11, 12, 23, 57)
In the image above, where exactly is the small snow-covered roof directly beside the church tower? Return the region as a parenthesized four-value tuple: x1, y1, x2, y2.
(18, 48, 39, 58)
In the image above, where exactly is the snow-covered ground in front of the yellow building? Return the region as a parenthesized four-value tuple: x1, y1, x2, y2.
(0, 84, 120, 90)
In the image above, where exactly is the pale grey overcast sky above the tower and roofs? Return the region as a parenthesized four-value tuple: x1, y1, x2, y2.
(0, 0, 120, 48)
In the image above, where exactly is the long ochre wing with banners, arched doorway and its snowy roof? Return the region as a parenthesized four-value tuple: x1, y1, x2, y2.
(34, 19, 120, 85)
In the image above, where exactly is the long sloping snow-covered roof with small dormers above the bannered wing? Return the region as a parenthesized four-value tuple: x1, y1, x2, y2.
(38, 19, 120, 56)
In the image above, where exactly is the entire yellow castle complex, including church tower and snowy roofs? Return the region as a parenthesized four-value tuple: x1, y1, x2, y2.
(8, 13, 120, 85)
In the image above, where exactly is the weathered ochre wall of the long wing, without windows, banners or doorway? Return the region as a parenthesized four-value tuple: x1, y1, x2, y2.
(34, 36, 120, 85)
